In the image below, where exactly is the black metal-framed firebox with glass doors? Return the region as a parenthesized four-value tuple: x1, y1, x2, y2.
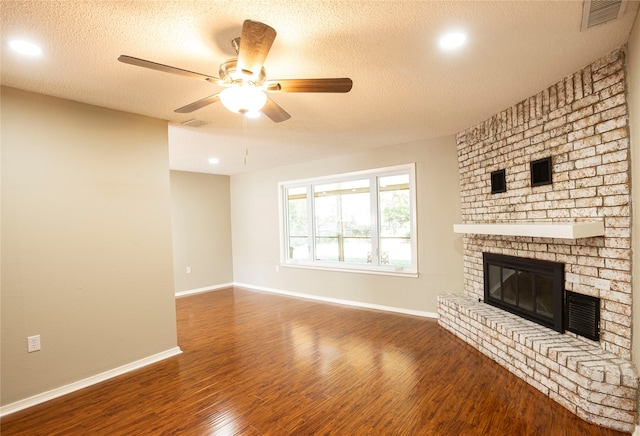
(483, 253, 564, 333)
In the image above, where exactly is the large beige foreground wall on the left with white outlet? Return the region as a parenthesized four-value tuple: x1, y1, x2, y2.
(1, 88, 177, 405)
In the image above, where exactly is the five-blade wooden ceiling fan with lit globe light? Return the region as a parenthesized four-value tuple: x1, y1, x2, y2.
(118, 20, 353, 123)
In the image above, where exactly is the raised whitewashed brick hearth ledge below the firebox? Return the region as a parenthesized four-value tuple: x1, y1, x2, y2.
(438, 294, 638, 433)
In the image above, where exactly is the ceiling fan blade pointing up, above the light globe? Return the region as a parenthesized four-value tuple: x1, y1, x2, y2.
(237, 20, 276, 77)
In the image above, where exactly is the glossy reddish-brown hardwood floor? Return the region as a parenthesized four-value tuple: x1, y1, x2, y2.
(0, 288, 623, 436)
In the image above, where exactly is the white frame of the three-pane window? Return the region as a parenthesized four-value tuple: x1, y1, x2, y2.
(278, 163, 418, 277)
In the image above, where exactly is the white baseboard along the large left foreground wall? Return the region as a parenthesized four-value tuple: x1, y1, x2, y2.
(0, 347, 182, 417)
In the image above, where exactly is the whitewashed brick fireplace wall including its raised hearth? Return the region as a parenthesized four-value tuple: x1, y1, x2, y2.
(439, 48, 638, 432)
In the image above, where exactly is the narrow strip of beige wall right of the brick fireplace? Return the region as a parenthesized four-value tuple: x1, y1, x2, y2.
(627, 12, 640, 365)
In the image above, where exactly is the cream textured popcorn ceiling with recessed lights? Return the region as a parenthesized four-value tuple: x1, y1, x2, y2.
(0, 0, 638, 174)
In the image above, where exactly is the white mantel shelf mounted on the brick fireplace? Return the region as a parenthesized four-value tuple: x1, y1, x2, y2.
(453, 221, 604, 239)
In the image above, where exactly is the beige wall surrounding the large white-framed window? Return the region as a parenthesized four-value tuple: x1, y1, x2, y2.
(231, 136, 462, 313)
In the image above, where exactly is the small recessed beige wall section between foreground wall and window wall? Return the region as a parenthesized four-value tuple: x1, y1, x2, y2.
(171, 171, 233, 293)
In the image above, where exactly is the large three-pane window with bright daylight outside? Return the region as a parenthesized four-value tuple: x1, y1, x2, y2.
(280, 164, 417, 275)
